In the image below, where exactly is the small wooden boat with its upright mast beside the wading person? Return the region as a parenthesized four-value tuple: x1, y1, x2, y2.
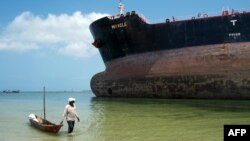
(29, 87, 63, 133)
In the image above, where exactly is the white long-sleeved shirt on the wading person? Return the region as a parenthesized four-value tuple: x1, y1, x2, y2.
(63, 104, 78, 121)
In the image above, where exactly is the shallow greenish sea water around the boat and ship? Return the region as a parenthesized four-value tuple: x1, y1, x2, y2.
(0, 91, 250, 141)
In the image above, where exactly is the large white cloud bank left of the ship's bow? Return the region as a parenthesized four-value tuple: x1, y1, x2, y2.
(0, 11, 108, 57)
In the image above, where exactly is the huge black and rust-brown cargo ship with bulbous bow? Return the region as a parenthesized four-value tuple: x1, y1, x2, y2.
(90, 3, 250, 99)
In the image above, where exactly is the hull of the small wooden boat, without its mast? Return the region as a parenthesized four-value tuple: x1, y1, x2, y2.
(29, 115, 63, 133)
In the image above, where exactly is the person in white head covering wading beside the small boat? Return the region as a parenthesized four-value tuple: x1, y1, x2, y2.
(61, 98, 80, 133)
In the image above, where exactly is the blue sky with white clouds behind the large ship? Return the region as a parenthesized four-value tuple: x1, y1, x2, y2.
(0, 0, 250, 91)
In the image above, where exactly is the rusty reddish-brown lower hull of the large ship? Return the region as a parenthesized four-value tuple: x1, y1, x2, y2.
(91, 42, 250, 99)
